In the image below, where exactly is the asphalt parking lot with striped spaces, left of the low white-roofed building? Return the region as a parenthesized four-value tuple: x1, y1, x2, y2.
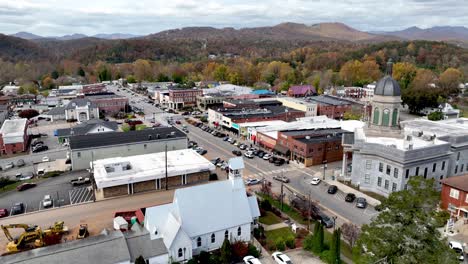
(0, 172, 94, 218)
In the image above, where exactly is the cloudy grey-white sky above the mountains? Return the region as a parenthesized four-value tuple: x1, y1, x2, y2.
(0, 0, 468, 36)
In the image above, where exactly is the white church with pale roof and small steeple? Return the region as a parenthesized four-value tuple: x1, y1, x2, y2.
(144, 157, 260, 261)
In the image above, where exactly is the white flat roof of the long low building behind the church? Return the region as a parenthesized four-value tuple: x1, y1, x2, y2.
(93, 149, 216, 188)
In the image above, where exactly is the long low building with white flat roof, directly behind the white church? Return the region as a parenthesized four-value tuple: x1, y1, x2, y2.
(93, 149, 216, 199)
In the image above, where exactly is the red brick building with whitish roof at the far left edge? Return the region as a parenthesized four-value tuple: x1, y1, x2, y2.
(0, 118, 28, 156)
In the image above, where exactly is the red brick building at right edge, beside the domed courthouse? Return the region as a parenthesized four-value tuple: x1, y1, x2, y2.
(440, 174, 468, 218)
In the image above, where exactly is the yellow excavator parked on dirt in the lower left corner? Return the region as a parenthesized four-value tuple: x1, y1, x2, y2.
(1, 222, 68, 254)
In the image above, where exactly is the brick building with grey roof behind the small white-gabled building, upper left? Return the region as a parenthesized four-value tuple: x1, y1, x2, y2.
(86, 93, 128, 114)
